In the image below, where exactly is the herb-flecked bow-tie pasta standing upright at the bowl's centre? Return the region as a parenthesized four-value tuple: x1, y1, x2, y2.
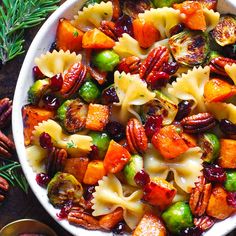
(114, 71, 155, 123)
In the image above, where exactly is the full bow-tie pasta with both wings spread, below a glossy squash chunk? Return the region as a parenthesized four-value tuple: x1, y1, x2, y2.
(144, 144, 203, 193)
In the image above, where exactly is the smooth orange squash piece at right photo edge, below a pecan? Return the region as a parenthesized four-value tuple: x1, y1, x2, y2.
(204, 78, 236, 102)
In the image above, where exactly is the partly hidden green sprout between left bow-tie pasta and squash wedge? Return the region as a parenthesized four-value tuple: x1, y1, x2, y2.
(89, 132, 111, 159)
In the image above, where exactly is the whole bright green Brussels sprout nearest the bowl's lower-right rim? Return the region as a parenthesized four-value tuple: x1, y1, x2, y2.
(162, 202, 193, 234)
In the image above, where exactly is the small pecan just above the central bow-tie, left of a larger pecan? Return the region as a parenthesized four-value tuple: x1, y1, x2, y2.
(117, 56, 141, 74)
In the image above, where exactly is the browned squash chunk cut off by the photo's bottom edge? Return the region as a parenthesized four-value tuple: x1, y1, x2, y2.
(132, 213, 167, 236)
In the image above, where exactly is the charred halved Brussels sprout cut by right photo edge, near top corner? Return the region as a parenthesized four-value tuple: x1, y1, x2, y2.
(211, 15, 236, 46)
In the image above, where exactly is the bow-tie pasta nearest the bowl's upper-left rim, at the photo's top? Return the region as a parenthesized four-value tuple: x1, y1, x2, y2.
(71, 1, 113, 31)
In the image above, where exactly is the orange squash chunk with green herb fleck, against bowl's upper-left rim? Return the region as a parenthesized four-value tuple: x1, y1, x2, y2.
(56, 19, 84, 52)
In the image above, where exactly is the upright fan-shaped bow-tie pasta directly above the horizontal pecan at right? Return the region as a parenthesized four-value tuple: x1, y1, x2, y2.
(168, 66, 210, 112)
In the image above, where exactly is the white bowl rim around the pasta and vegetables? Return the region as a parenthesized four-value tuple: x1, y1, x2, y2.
(12, 0, 236, 236)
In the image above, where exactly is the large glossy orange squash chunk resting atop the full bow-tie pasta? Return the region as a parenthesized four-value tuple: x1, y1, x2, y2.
(151, 125, 189, 159)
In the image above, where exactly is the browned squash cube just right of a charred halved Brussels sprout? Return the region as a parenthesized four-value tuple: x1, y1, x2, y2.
(86, 103, 110, 131)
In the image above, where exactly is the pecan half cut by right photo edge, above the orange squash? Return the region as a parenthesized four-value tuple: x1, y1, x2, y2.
(210, 57, 236, 76)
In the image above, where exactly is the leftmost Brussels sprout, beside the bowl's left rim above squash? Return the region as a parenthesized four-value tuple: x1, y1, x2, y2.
(28, 79, 49, 105)
